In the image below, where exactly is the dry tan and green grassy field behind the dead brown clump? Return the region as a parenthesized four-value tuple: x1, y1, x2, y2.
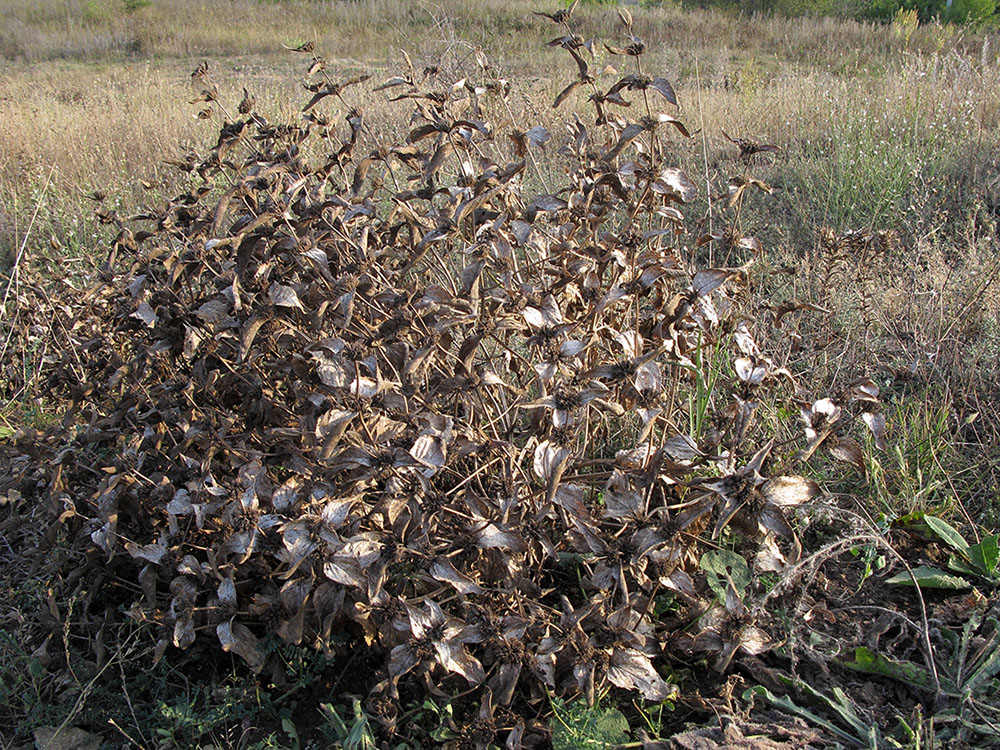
(0, 0, 1000, 746)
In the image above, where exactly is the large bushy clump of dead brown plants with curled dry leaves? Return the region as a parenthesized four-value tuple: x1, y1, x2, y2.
(4, 4, 884, 747)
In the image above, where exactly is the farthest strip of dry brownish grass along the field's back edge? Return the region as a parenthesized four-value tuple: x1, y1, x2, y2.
(0, 0, 988, 65)
